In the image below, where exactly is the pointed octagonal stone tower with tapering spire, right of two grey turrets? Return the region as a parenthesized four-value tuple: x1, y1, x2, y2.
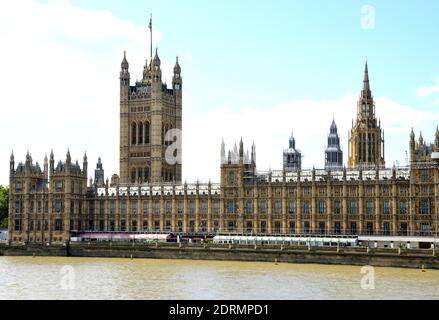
(348, 62, 385, 169)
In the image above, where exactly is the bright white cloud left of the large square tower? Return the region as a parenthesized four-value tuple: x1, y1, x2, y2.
(0, 0, 172, 184)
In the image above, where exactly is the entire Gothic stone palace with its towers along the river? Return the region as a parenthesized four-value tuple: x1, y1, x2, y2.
(9, 26, 439, 244)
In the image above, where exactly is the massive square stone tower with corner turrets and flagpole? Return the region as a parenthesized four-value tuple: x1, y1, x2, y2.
(120, 19, 183, 184)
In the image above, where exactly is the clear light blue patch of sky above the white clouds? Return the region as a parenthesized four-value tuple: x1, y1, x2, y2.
(66, 0, 439, 109)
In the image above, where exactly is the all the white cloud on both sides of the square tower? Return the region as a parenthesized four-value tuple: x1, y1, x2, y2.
(0, 0, 439, 184)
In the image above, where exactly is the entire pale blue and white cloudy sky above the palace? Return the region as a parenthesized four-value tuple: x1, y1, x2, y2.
(0, 0, 439, 185)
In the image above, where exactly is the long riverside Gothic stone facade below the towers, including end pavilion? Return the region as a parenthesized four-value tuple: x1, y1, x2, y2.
(9, 140, 439, 243)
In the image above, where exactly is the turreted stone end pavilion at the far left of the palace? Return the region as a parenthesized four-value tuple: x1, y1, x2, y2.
(9, 152, 89, 243)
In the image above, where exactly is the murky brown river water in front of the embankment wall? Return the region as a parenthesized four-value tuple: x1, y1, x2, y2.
(0, 257, 439, 300)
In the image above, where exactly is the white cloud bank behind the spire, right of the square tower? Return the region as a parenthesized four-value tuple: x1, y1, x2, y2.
(183, 94, 439, 181)
